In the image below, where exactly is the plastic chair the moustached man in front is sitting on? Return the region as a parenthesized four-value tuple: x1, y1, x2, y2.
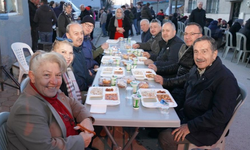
(178, 84, 247, 150)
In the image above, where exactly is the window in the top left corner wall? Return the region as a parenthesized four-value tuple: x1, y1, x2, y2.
(0, 0, 17, 14)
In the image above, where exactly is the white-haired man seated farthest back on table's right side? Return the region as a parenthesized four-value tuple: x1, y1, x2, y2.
(140, 19, 152, 43)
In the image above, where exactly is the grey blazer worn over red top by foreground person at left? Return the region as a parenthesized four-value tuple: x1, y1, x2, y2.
(7, 84, 93, 150)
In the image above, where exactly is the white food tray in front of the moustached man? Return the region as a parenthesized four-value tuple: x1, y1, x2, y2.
(139, 89, 177, 108)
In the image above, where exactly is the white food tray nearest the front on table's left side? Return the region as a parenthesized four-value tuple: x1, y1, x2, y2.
(86, 87, 120, 105)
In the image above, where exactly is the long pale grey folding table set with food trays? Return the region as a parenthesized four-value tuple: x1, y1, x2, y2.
(86, 48, 180, 150)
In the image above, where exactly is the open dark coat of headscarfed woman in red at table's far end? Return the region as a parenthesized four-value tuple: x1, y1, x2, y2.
(108, 16, 131, 39)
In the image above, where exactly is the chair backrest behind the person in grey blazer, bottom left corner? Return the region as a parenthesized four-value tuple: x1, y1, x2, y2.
(0, 112, 10, 150)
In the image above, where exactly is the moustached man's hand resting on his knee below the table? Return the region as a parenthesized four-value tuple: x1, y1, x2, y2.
(172, 124, 190, 142)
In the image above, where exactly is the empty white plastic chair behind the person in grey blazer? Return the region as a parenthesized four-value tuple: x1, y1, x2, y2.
(11, 42, 33, 94)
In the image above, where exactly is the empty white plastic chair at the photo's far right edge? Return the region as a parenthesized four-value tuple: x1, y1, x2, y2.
(231, 32, 250, 64)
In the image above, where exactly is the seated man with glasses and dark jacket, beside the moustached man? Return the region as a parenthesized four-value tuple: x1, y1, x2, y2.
(148, 22, 202, 98)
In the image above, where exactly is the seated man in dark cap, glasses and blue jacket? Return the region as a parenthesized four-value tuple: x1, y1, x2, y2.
(81, 15, 108, 74)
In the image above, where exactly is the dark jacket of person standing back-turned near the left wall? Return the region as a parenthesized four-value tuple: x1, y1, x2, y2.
(34, 4, 57, 32)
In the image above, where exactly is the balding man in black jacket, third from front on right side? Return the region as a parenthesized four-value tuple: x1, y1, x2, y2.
(143, 22, 184, 66)
